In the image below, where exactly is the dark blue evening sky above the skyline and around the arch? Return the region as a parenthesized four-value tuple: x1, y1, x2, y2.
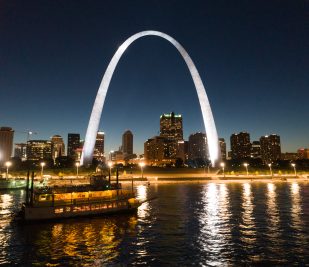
(0, 0, 309, 153)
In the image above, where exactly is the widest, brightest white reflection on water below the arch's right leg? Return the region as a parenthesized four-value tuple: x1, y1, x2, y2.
(199, 183, 231, 265)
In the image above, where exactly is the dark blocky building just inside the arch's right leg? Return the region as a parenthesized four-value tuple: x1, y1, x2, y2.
(188, 133, 208, 161)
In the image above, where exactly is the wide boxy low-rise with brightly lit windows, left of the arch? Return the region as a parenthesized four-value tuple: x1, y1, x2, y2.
(27, 140, 52, 160)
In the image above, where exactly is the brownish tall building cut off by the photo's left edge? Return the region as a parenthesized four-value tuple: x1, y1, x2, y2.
(0, 127, 14, 164)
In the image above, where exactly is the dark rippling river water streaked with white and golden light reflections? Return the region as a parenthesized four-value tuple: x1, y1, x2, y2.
(0, 182, 309, 266)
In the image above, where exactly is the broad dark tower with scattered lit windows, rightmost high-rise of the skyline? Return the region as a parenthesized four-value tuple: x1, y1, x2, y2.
(260, 134, 281, 163)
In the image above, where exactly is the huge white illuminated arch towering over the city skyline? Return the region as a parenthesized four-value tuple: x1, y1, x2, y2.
(80, 31, 219, 166)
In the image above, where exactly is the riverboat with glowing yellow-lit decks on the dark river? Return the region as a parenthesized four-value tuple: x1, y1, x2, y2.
(21, 173, 141, 221)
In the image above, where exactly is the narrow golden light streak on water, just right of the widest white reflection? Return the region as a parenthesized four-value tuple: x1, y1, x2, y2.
(240, 183, 256, 244)
